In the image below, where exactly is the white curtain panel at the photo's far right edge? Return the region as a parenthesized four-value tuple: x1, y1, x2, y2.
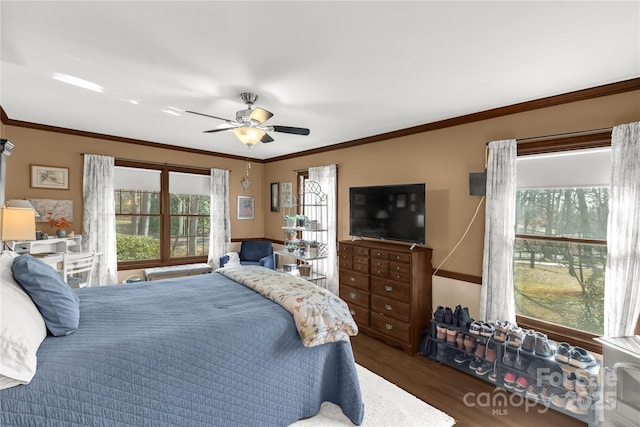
(604, 122, 640, 337)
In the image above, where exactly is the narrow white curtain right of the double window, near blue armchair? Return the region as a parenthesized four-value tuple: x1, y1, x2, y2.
(207, 169, 231, 269)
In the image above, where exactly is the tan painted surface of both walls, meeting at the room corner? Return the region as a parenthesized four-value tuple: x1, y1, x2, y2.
(1, 91, 640, 286)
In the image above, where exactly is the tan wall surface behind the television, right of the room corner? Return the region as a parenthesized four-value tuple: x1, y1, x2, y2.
(265, 91, 640, 276)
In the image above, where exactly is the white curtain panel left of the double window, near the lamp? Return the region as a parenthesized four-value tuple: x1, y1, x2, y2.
(82, 154, 118, 286)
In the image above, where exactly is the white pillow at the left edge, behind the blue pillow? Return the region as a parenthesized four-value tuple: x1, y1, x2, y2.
(0, 251, 47, 390)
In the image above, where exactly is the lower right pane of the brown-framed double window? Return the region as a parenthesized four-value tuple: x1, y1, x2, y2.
(171, 215, 209, 258)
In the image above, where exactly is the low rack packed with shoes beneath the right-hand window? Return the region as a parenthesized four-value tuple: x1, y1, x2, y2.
(421, 310, 601, 426)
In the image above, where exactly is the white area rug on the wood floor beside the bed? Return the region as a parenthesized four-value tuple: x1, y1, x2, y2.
(290, 365, 455, 427)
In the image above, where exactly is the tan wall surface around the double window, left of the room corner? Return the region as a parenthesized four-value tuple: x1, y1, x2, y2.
(2, 125, 269, 238)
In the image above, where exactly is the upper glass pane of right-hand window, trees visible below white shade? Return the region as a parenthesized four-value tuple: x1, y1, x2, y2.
(516, 188, 609, 240)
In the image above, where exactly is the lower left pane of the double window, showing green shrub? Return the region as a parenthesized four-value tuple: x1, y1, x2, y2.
(116, 215, 160, 262)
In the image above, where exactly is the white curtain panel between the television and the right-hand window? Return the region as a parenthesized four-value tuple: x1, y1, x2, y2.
(480, 139, 517, 322)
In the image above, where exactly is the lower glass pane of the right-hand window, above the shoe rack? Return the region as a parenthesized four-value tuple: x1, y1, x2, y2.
(513, 239, 607, 335)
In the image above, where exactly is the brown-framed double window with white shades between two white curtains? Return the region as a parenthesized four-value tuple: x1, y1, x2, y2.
(115, 161, 210, 268)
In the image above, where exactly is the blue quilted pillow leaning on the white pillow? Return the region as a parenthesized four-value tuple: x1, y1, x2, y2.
(13, 254, 80, 337)
